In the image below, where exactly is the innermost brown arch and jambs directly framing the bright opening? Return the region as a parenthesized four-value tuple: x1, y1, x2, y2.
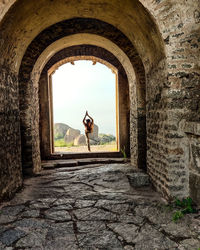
(39, 45, 130, 162)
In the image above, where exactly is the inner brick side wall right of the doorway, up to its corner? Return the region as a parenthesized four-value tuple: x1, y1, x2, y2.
(146, 61, 173, 199)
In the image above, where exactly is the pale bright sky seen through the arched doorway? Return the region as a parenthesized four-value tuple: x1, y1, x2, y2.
(52, 60, 116, 136)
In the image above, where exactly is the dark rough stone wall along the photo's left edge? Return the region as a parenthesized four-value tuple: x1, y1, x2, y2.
(0, 66, 22, 200)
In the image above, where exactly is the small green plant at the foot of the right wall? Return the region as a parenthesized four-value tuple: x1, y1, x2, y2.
(172, 197, 197, 222)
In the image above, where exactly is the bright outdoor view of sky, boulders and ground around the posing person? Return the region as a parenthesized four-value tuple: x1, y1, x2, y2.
(52, 60, 117, 153)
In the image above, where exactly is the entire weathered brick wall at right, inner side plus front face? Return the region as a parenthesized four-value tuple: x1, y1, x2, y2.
(142, 0, 200, 202)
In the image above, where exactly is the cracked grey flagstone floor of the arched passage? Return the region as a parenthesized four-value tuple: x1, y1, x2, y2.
(0, 163, 200, 250)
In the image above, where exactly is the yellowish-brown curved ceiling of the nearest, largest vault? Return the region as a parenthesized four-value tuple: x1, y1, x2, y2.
(0, 0, 163, 71)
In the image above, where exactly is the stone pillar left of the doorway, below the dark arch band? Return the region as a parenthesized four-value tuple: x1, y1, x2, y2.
(19, 75, 41, 175)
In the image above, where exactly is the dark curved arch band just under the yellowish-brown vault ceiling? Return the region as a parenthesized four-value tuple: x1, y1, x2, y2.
(19, 18, 143, 81)
